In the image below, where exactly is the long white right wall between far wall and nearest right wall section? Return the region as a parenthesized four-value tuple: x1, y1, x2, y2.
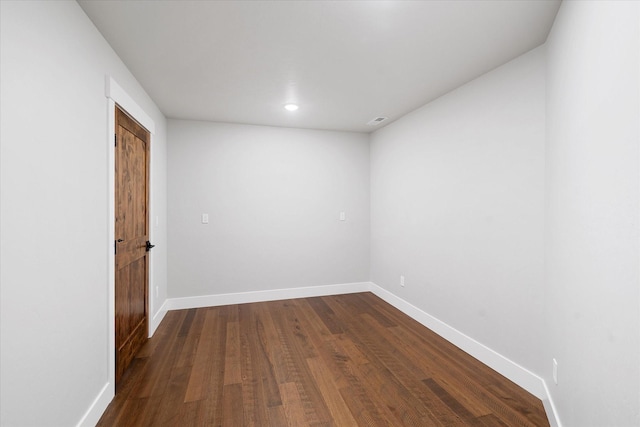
(371, 48, 545, 372)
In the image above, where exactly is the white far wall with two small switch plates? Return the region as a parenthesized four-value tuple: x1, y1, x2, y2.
(168, 121, 369, 297)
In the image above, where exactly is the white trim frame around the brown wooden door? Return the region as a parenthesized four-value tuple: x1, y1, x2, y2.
(105, 75, 156, 396)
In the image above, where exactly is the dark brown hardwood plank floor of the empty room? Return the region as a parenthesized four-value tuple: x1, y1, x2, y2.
(98, 293, 549, 427)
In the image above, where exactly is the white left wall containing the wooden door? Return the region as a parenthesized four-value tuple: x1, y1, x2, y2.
(0, 1, 167, 426)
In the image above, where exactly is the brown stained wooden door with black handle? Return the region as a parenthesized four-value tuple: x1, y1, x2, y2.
(115, 107, 151, 386)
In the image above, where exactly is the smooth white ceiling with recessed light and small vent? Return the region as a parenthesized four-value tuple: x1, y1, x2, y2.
(79, 0, 560, 132)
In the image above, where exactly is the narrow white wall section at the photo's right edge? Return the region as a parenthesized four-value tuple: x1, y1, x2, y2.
(544, 1, 640, 427)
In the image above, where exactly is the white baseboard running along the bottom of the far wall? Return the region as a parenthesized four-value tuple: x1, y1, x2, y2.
(166, 282, 371, 310)
